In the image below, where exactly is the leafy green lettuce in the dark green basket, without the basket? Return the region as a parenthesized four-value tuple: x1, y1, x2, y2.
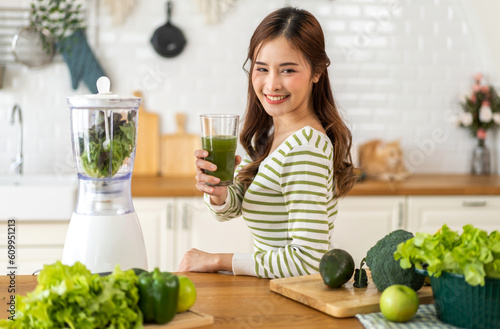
(394, 225, 500, 286)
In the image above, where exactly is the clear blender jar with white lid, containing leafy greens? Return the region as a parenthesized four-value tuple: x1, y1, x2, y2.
(67, 80, 141, 215)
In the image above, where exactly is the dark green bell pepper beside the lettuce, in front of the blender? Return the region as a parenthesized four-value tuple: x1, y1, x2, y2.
(138, 267, 179, 324)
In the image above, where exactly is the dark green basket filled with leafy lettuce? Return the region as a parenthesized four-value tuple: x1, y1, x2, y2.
(394, 225, 500, 329)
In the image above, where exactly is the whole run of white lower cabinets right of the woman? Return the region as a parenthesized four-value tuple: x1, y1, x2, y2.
(332, 195, 500, 266)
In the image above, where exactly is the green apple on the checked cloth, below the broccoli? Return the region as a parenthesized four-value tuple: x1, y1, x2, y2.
(380, 284, 420, 322)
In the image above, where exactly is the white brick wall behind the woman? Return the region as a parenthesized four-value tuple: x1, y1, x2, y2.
(0, 0, 498, 174)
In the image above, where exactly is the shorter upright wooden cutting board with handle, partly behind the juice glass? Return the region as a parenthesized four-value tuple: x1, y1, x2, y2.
(161, 113, 201, 177)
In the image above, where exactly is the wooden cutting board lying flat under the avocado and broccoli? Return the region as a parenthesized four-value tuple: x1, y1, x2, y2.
(270, 271, 434, 318)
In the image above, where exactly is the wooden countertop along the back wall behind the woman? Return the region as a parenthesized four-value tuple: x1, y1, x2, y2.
(132, 174, 500, 197)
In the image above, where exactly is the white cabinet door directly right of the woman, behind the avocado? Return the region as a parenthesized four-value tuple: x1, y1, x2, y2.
(331, 196, 405, 267)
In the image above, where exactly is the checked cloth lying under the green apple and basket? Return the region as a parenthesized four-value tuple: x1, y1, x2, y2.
(356, 304, 459, 329)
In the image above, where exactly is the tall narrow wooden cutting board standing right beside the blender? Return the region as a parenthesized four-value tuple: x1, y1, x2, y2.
(132, 91, 160, 177)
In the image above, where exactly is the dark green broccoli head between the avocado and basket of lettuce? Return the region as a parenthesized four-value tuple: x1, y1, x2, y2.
(366, 230, 425, 291)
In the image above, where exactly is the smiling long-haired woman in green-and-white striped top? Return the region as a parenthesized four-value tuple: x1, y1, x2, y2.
(178, 7, 355, 278)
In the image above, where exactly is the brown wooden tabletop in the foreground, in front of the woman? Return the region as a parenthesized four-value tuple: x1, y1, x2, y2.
(0, 273, 364, 329)
